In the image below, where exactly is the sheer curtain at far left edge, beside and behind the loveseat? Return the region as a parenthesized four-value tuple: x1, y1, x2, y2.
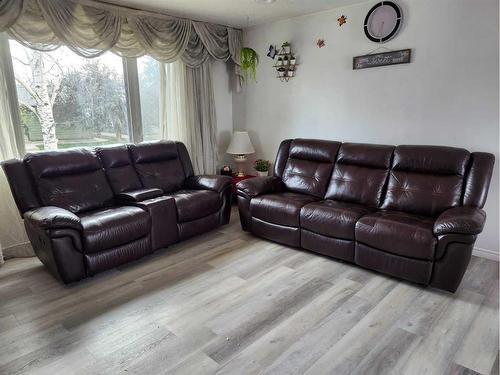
(0, 35, 33, 264)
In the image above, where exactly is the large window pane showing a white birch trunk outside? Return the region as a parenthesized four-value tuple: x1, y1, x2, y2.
(10, 41, 130, 151)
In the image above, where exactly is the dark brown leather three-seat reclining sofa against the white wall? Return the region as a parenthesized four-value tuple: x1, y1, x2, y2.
(237, 139, 494, 292)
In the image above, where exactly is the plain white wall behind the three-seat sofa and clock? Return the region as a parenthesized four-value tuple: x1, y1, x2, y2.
(233, 0, 499, 254)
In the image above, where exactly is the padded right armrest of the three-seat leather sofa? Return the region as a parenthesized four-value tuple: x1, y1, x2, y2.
(434, 206, 486, 236)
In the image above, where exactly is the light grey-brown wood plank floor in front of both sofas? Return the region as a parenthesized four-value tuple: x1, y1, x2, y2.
(0, 210, 498, 375)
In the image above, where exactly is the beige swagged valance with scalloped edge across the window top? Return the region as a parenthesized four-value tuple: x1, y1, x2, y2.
(0, 0, 242, 76)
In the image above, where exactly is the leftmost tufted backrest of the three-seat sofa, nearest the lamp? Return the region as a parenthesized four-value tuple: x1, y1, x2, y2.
(275, 139, 340, 198)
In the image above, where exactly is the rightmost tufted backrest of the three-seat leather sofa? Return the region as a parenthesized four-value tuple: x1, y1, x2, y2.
(382, 146, 470, 216)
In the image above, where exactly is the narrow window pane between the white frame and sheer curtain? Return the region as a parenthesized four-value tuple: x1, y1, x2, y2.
(137, 56, 160, 141)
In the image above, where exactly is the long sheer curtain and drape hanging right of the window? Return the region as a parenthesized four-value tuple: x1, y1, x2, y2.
(160, 61, 218, 174)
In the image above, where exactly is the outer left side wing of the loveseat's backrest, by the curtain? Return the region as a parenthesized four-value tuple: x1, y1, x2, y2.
(1, 159, 40, 216)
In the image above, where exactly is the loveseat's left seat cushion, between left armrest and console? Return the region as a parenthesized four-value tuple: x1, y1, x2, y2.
(79, 206, 151, 253)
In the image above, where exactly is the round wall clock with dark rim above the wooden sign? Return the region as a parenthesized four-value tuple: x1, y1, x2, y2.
(365, 1, 403, 43)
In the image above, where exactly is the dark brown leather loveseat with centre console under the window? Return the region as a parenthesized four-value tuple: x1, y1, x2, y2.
(2, 141, 231, 283)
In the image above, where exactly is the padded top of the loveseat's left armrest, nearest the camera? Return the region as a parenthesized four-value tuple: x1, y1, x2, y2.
(24, 206, 83, 231)
